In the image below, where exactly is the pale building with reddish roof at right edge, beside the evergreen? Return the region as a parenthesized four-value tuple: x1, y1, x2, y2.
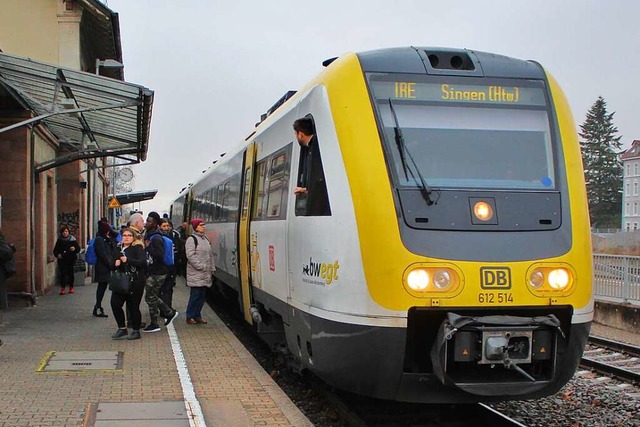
(621, 139, 640, 231)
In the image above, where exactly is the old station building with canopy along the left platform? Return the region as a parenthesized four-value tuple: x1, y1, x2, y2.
(0, 0, 153, 310)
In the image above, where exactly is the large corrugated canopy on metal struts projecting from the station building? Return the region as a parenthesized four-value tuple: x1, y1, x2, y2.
(0, 53, 153, 172)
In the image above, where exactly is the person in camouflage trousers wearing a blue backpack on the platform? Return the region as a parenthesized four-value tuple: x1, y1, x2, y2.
(142, 212, 178, 332)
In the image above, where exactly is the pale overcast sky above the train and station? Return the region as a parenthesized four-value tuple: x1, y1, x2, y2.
(103, 0, 640, 213)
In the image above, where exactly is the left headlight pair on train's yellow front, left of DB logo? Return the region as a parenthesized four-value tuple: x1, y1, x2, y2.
(403, 263, 462, 298)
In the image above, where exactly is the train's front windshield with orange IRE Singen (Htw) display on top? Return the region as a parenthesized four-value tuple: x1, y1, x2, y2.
(370, 75, 555, 190)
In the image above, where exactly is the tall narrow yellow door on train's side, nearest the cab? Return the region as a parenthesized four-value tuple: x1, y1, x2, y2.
(238, 143, 256, 325)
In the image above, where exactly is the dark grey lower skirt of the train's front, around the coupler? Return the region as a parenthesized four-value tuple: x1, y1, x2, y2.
(284, 307, 590, 403)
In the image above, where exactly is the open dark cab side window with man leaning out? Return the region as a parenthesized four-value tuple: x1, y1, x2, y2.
(295, 114, 331, 216)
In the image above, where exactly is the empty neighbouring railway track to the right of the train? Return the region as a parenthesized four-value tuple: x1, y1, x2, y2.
(580, 336, 640, 384)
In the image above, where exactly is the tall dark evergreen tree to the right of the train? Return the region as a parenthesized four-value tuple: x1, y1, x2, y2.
(579, 96, 622, 228)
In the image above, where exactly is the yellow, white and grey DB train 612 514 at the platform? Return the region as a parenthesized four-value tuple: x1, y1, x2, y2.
(172, 47, 593, 402)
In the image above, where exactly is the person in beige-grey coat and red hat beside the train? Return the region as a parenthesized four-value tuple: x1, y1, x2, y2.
(185, 218, 216, 325)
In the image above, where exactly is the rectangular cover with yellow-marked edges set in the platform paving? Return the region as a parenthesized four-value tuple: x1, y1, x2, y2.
(36, 351, 124, 372)
